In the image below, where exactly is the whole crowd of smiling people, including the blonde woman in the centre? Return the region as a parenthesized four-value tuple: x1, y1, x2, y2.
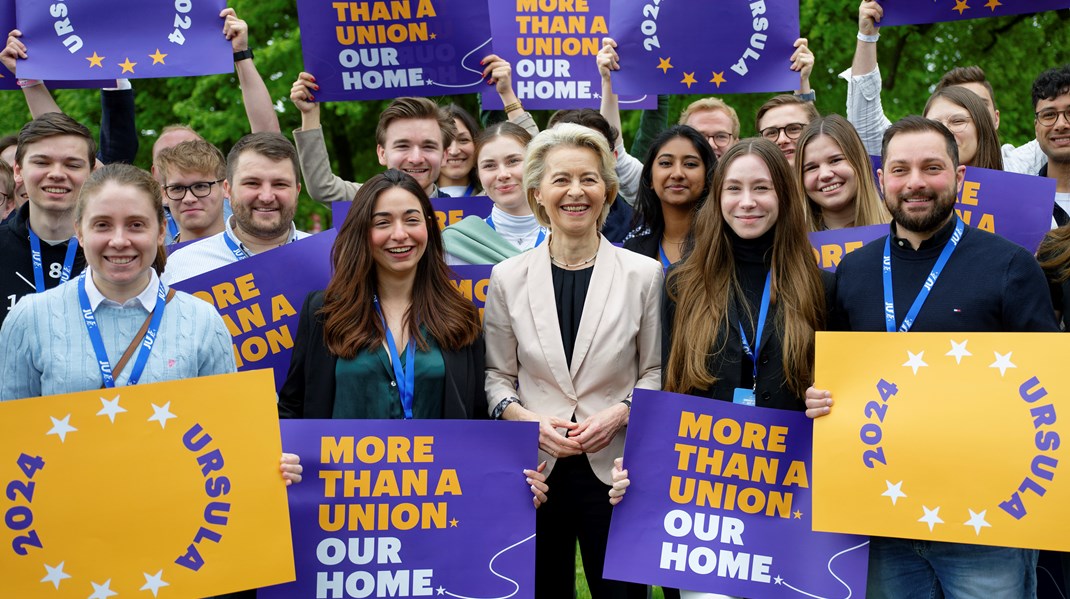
(0, 0, 1070, 598)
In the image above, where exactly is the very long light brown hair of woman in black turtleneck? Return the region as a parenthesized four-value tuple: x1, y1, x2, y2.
(664, 138, 825, 397)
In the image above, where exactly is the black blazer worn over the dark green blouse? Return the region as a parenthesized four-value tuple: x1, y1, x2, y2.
(278, 291, 488, 418)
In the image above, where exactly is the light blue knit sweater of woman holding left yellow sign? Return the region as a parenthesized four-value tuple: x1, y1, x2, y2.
(0, 280, 235, 400)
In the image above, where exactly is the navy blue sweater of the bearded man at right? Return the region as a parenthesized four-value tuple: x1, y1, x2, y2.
(831, 219, 1058, 333)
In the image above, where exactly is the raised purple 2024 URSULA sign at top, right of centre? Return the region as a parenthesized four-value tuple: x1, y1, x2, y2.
(610, 0, 799, 94)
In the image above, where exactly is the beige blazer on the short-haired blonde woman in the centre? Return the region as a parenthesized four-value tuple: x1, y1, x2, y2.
(484, 237, 664, 485)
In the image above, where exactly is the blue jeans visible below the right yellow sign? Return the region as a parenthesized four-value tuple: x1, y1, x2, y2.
(866, 537, 1038, 599)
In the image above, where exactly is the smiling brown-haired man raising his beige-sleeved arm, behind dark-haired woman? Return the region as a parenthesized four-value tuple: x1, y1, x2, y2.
(290, 89, 457, 202)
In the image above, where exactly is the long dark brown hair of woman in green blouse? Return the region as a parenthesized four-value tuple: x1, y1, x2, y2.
(319, 169, 479, 359)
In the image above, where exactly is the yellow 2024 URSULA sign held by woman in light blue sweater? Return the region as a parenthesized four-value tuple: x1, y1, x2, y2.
(0, 370, 294, 599)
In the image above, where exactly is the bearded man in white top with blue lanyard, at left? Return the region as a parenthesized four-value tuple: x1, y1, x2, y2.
(162, 133, 308, 285)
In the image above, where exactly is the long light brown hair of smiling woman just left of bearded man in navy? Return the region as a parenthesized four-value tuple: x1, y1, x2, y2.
(795, 114, 891, 231)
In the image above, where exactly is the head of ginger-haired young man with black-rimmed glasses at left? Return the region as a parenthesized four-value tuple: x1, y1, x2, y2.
(153, 140, 227, 243)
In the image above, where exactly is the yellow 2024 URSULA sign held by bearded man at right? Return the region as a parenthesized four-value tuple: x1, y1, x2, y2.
(813, 333, 1070, 551)
